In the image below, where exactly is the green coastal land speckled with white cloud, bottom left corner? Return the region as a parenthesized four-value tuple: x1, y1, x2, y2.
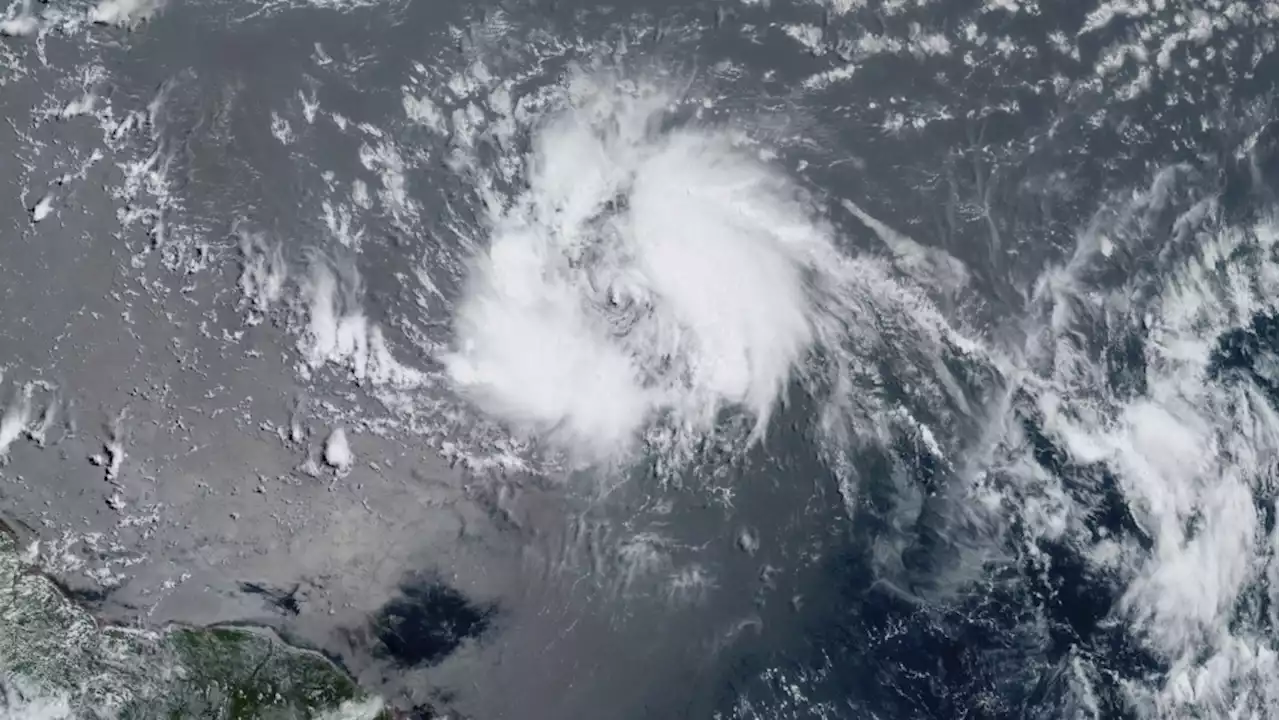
(0, 524, 394, 720)
